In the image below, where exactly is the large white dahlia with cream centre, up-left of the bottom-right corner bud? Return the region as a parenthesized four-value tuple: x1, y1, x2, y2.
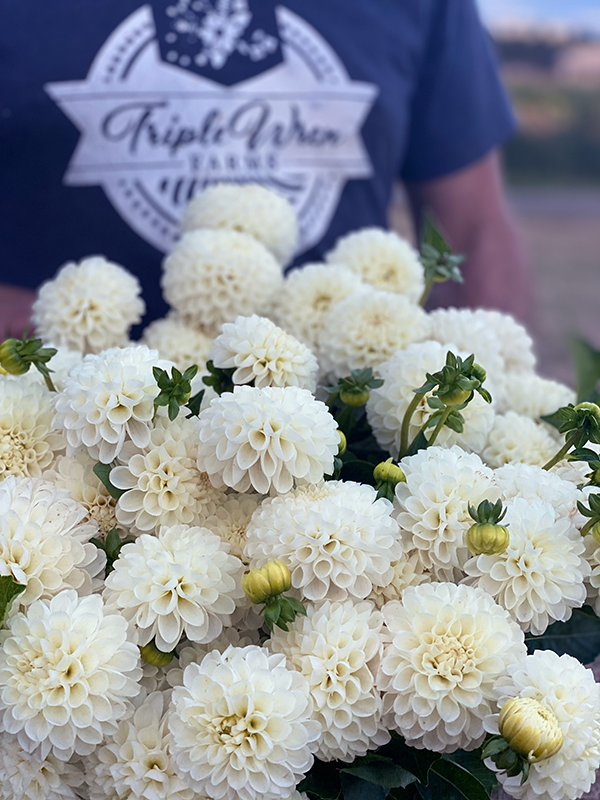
(378, 583, 527, 753)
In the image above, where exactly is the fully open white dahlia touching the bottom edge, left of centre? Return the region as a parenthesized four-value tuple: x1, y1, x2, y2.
(169, 646, 321, 800)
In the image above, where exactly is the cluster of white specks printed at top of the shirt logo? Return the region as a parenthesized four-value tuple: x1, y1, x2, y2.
(165, 0, 277, 70)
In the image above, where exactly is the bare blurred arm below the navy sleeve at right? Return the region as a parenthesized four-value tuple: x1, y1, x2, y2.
(406, 151, 531, 320)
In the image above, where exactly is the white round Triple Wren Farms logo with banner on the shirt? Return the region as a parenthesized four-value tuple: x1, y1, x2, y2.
(45, 0, 378, 253)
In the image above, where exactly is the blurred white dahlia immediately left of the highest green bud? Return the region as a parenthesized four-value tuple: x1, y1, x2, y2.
(325, 228, 425, 303)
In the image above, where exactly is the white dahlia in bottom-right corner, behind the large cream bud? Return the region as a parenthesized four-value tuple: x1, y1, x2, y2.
(485, 650, 600, 800)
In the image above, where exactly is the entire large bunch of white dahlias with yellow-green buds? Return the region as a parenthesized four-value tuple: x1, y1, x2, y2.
(0, 181, 600, 800)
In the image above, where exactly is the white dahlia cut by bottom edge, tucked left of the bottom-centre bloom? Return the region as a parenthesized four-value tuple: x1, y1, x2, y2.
(85, 692, 191, 800)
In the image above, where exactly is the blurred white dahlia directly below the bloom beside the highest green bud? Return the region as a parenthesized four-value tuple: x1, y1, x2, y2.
(318, 289, 429, 380)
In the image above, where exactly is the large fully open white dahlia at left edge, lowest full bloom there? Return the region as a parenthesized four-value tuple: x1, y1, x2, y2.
(0, 590, 142, 761)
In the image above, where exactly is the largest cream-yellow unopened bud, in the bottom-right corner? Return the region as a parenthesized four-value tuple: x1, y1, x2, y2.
(498, 697, 563, 764)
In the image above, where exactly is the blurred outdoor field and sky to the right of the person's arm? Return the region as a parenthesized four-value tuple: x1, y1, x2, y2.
(393, 0, 600, 383)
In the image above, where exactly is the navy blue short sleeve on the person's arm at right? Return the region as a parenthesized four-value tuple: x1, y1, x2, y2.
(400, 0, 515, 182)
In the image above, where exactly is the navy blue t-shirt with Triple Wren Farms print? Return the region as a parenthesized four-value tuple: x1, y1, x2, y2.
(0, 0, 513, 318)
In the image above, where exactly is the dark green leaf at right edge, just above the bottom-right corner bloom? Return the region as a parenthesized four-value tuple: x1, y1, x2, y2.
(525, 608, 600, 664)
